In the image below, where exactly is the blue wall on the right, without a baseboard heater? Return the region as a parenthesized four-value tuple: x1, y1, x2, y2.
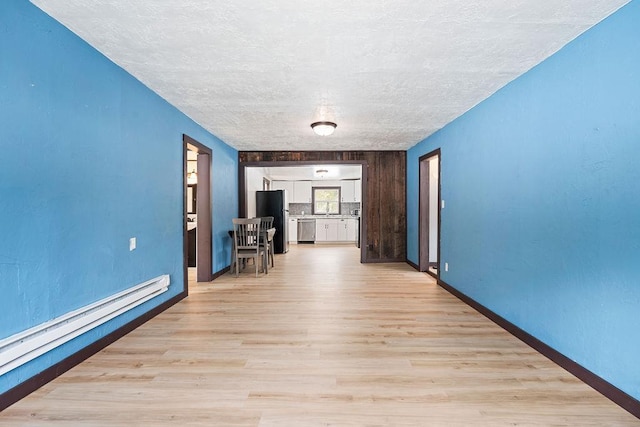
(407, 1, 640, 399)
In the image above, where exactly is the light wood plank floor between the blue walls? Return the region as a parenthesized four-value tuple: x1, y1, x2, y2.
(0, 245, 640, 427)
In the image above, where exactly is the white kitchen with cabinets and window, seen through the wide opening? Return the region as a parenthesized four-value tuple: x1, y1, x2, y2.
(245, 165, 362, 248)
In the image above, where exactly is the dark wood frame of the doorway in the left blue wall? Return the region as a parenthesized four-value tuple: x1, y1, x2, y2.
(182, 135, 213, 287)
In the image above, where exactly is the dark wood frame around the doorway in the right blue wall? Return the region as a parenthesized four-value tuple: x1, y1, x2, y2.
(418, 148, 442, 279)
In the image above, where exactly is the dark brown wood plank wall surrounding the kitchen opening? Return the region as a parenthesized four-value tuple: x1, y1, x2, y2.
(238, 151, 407, 262)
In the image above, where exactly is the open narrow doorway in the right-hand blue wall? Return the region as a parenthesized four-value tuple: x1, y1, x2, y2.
(418, 149, 440, 278)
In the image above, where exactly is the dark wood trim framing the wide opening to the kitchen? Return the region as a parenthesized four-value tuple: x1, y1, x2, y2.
(238, 160, 368, 263)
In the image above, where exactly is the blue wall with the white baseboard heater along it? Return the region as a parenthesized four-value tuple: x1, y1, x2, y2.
(0, 0, 238, 392)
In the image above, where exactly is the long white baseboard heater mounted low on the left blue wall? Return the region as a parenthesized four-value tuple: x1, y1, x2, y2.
(0, 274, 169, 375)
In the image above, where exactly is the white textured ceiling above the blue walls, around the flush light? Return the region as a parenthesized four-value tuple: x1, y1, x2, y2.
(32, 0, 627, 150)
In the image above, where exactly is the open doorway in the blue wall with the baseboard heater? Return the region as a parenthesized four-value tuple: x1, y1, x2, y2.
(183, 135, 213, 282)
